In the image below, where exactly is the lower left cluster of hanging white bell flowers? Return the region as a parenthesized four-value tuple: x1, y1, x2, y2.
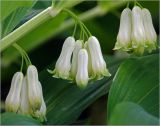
(5, 65, 46, 122)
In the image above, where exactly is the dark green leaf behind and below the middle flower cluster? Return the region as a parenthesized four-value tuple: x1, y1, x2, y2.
(39, 55, 122, 125)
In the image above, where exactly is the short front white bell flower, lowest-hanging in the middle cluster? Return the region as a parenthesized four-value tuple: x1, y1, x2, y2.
(76, 49, 89, 87)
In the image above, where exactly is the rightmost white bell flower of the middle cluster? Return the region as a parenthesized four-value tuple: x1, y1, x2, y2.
(88, 36, 111, 79)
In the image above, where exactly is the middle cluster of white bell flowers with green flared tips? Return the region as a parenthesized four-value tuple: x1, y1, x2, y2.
(49, 36, 110, 87)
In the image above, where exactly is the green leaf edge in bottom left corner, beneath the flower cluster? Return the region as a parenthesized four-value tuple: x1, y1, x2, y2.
(1, 112, 42, 126)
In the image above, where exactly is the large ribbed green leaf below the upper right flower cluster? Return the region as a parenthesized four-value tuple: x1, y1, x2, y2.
(108, 54, 159, 118)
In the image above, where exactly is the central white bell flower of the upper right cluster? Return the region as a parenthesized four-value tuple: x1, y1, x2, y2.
(132, 6, 146, 48)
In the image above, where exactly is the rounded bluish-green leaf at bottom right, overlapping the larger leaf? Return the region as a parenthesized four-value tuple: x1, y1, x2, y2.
(108, 102, 159, 125)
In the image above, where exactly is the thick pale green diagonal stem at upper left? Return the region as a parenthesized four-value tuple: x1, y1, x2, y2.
(0, 7, 59, 52)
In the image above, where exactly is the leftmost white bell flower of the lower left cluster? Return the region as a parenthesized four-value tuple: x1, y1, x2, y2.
(5, 72, 23, 112)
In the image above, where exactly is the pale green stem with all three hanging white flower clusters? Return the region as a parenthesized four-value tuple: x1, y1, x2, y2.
(1, 1, 157, 125)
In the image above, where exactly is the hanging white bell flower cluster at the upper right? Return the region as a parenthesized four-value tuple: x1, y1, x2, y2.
(114, 6, 157, 54)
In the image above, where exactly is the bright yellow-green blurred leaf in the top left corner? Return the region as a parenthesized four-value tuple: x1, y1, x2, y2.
(0, 0, 34, 21)
